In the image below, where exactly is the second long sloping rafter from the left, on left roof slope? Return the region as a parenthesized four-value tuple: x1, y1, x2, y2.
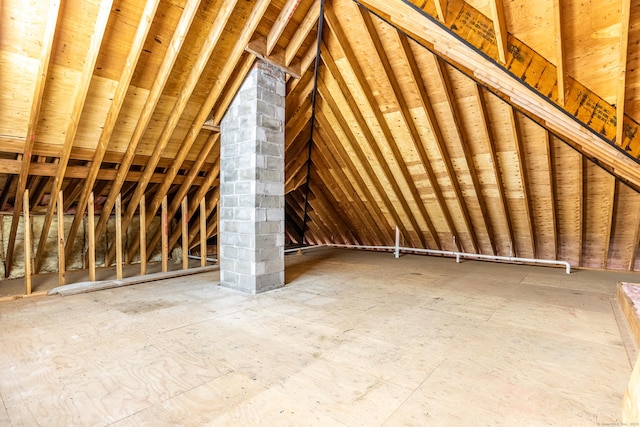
(34, 0, 113, 273)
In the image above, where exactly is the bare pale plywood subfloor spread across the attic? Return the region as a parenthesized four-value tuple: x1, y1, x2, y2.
(0, 250, 638, 426)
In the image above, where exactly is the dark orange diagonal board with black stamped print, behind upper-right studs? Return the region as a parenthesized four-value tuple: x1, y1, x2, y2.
(403, 0, 640, 160)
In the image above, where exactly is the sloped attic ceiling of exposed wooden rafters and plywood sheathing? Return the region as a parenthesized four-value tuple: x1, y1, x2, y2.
(0, 0, 640, 272)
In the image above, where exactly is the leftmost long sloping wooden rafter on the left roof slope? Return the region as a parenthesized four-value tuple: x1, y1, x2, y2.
(5, 0, 60, 280)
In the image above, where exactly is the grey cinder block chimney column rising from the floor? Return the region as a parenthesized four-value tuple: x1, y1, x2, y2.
(219, 60, 286, 294)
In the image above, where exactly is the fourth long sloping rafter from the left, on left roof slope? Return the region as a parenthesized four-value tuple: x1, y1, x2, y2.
(96, 0, 202, 264)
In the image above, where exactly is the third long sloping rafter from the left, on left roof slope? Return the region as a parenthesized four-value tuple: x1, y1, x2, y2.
(66, 0, 160, 255)
